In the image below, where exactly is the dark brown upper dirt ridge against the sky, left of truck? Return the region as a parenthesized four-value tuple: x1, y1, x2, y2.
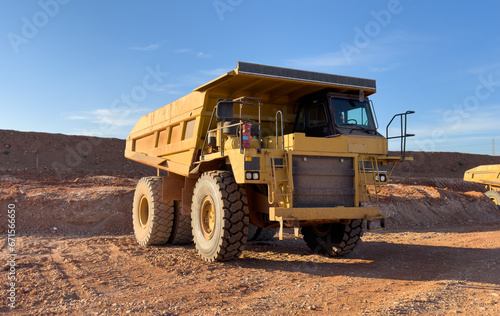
(0, 130, 155, 178)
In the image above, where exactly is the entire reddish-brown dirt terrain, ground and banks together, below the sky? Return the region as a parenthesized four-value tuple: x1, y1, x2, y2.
(0, 130, 500, 315)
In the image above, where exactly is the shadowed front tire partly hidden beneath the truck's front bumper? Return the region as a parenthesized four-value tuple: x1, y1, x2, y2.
(302, 219, 363, 257)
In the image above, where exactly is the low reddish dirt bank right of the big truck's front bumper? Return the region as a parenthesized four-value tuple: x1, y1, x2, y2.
(366, 178, 500, 229)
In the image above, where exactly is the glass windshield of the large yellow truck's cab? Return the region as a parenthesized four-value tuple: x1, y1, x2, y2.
(330, 97, 376, 130)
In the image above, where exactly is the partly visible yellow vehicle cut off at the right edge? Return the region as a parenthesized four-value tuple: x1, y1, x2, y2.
(464, 165, 500, 208)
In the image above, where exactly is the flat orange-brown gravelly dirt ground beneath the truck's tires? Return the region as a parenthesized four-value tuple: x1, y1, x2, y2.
(0, 224, 500, 315)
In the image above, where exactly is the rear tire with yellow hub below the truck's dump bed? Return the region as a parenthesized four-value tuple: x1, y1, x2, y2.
(132, 177, 174, 246)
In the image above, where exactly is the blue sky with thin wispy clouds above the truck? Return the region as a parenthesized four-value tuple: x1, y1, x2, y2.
(0, 0, 500, 154)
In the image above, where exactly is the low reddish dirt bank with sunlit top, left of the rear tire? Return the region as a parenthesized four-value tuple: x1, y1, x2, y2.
(0, 176, 135, 236)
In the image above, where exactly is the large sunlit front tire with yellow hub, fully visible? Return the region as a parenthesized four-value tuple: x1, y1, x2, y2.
(191, 171, 248, 262)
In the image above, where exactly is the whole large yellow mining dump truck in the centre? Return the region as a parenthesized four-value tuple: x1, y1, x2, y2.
(125, 62, 413, 261)
